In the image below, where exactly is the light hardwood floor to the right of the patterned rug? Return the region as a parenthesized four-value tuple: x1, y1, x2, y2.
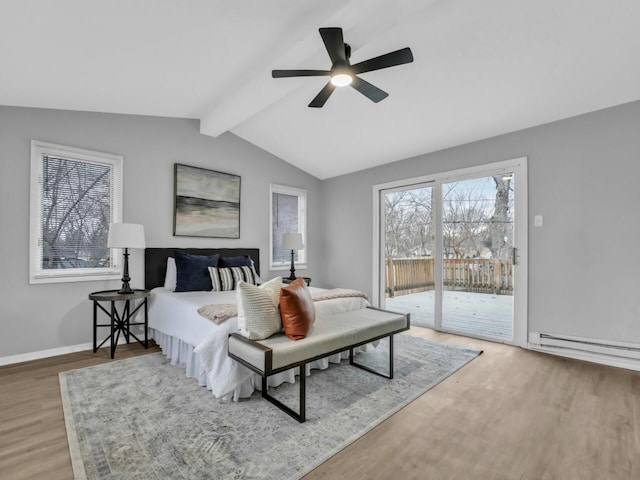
(305, 328, 640, 480)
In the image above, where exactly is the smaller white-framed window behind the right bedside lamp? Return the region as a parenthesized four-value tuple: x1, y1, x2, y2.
(270, 184, 307, 270)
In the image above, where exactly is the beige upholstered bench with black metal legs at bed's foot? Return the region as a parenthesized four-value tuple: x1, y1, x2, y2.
(228, 307, 410, 423)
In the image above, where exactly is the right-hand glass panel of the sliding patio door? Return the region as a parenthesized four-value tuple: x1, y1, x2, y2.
(441, 172, 514, 342)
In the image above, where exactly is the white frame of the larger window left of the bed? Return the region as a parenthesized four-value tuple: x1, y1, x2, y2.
(29, 140, 124, 284)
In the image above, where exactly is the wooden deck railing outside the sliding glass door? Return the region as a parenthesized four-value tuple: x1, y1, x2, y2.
(386, 257, 513, 297)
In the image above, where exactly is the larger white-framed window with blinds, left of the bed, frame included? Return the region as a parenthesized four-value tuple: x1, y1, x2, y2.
(29, 140, 123, 283)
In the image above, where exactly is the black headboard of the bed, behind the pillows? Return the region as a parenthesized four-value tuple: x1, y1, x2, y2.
(144, 248, 260, 290)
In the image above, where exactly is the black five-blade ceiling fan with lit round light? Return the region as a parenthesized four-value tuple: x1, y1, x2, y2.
(271, 27, 413, 108)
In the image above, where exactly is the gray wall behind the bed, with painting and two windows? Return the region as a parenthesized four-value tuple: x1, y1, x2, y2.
(0, 106, 321, 357)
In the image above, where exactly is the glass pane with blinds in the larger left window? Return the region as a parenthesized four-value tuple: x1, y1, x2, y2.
(41, 154, 113, 270)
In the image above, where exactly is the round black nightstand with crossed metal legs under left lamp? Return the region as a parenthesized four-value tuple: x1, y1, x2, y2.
(89, 290, 150, 358)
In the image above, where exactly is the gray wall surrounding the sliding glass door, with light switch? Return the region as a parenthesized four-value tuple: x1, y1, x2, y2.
(318, 102, 640, 343)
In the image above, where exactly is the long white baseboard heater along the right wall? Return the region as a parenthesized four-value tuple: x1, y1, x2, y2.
(529, 332, 640, 370)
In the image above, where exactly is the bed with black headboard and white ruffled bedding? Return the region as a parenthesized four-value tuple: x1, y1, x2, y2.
(145, 248, 371, 401)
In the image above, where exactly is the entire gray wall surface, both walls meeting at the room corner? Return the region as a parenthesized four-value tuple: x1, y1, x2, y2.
(5, 102, 640, 357)
